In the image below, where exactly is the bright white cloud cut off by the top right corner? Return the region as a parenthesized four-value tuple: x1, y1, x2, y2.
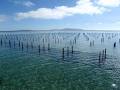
(97, 0, 120, 7)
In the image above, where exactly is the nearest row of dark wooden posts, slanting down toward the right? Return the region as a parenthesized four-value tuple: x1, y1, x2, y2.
(0, 39, 106, 64)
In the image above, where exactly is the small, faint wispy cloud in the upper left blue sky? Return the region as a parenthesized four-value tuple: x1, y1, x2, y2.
(11, 0, 35, 7)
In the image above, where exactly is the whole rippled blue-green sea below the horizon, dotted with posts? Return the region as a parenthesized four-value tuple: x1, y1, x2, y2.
(0, 31, 120, 90)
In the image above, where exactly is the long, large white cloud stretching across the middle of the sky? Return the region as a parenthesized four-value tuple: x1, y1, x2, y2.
(16, 0, 108, 19)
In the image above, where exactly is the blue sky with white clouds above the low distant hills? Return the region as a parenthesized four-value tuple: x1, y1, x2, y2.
(0, 0, 120, 31)
